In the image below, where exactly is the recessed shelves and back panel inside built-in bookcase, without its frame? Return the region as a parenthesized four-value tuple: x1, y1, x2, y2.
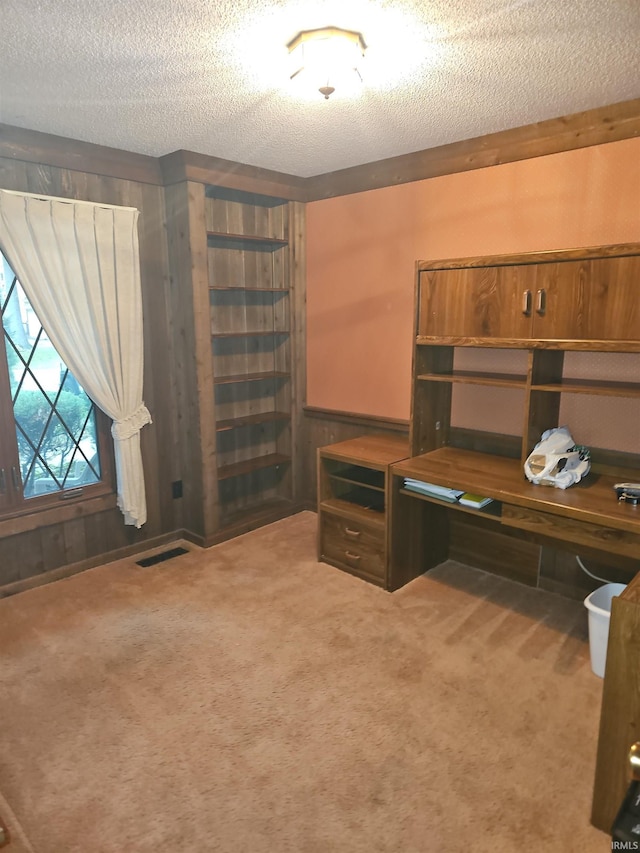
(205, 186, 292, 527)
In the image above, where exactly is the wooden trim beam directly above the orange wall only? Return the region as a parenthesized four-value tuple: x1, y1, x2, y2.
(306, 98, 640, 201)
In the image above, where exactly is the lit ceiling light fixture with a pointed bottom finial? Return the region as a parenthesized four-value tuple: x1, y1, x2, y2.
(287, 27, 367, 100)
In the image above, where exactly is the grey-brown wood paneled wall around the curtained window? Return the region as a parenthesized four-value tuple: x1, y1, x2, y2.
(0, 152, 181, 590)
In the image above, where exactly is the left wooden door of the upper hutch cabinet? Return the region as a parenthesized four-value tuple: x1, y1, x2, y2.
(417, 264, 536, 340)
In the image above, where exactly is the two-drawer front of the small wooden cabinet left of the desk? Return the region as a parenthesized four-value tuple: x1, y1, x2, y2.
(320, 513, 385, 579)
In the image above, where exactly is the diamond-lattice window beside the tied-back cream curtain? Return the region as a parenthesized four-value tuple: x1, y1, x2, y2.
(0, 248, 112, 512)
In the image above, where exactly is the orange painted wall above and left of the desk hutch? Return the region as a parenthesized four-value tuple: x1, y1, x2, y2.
(307, 138, 640, 419)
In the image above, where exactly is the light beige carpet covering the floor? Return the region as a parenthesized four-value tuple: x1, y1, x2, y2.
(0, 512, 610, 853)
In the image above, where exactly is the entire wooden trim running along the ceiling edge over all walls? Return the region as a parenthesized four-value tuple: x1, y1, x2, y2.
(0, 98, 640, 202)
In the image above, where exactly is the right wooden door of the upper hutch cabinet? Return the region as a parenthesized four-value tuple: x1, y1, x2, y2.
(533, 256, 640, 341)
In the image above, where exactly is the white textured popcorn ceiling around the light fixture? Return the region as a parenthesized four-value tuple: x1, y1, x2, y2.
(0, 0, 640, 177)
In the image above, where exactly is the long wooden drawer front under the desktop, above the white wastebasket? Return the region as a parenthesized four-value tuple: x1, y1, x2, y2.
(502, 504, 640, 559)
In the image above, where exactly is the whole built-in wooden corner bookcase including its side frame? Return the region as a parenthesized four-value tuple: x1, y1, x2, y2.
(166, 176, 304, 544)
